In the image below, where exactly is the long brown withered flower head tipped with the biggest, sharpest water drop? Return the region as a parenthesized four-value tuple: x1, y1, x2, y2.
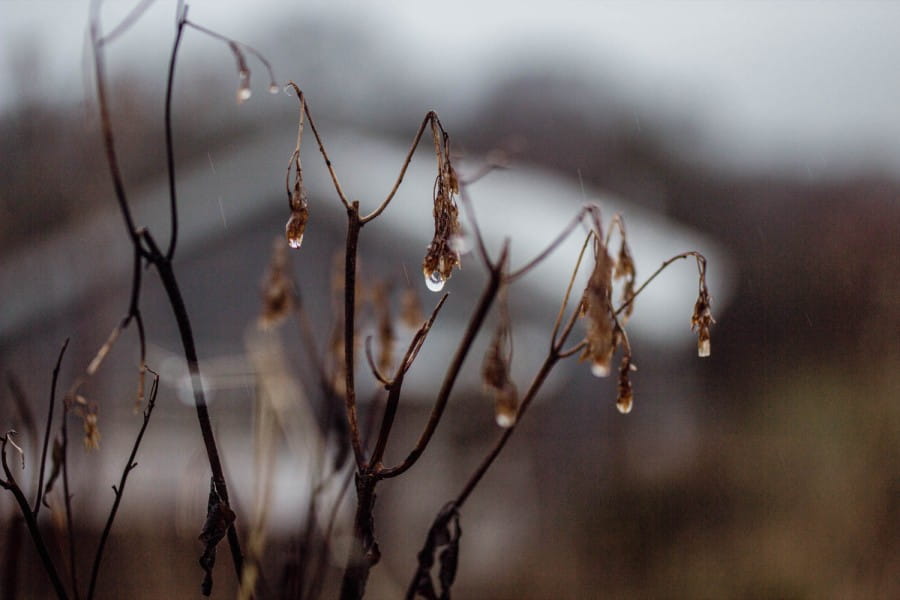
(422, 158, 460, 292)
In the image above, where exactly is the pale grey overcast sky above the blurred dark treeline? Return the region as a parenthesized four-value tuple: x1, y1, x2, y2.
(0, 0, 900, 173)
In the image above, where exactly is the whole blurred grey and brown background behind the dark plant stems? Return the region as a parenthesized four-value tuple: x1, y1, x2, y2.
(0, 0, 900, 598)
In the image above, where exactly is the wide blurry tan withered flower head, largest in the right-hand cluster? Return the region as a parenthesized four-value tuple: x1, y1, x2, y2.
(581, 243, 619, 377)
